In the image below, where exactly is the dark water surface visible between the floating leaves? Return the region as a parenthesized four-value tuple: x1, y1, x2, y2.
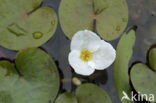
(0, 0, 156, 103)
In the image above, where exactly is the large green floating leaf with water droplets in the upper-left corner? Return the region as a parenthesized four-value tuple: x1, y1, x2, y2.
(0, 0, 57, 50)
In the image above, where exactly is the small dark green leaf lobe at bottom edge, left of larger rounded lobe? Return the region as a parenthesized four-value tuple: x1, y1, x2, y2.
(55, 93, 78, 103)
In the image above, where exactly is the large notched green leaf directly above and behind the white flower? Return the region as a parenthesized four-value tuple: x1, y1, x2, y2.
(59, 0, 128, 40)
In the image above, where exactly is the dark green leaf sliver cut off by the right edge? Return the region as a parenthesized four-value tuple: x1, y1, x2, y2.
(148, 48, 156, 70)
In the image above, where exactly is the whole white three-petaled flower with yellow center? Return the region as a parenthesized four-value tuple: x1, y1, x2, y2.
(68, 30, 116, 75)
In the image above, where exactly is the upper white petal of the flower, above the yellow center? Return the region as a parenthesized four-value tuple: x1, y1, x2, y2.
(71, 30, 101, 52)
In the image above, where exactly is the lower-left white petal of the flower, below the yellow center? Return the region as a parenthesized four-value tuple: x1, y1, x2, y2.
(68, 50, 95, 75)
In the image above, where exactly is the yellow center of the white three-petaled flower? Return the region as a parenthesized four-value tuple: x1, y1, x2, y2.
(80, 50, 92, 62)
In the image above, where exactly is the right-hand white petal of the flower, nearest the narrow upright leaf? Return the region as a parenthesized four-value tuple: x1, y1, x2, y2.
(88, 40, 116, 70)
